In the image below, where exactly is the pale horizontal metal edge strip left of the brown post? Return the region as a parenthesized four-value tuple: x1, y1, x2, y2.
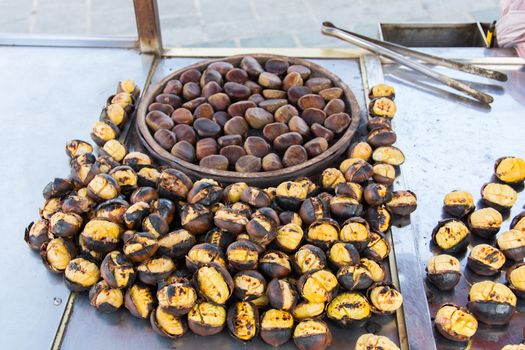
(0, 34, 138, 49)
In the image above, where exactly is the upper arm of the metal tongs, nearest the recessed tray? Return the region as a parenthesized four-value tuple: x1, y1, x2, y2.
(341, 29, 508, 81)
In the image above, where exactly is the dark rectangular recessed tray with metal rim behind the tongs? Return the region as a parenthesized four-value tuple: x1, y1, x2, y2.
(379, 22, 488, 47)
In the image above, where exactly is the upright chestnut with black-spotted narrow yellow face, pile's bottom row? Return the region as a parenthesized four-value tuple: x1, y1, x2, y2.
(227, 301, 259, 341)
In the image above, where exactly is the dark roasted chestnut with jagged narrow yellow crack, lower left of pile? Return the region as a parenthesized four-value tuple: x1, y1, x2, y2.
(100, 250, 136, 289)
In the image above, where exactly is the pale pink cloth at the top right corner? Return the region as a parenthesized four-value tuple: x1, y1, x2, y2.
(496, 0, 525, 57)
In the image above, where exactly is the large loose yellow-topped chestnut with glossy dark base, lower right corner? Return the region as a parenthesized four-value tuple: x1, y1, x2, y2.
(467, 281, 516, 325)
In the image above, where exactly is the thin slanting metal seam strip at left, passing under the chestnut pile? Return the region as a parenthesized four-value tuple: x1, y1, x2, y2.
(51, 56, 160, 350)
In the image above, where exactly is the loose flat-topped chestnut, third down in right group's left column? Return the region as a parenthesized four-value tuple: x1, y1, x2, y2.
(426, 254, 461, 291)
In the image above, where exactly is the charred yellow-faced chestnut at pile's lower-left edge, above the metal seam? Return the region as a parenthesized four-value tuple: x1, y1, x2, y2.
(64, 258, 100, 292)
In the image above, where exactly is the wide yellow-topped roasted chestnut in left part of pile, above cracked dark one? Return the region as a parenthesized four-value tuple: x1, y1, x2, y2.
(81, 218, 124, 253)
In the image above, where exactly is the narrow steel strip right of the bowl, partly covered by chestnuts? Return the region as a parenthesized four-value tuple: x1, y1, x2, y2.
(361, 55, 436, 350)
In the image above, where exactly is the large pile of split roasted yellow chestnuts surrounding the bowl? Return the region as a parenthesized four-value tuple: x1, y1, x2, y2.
(25, 81, 416, 350)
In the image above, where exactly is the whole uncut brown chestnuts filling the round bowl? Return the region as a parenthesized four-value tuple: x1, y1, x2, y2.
(146, 56, 351, 172)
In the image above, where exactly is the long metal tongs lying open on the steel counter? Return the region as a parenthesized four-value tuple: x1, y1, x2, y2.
(321, 22, 507, 104)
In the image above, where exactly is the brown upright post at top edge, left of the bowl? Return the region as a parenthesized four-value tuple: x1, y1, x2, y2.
(133, 0, 162, 56)
